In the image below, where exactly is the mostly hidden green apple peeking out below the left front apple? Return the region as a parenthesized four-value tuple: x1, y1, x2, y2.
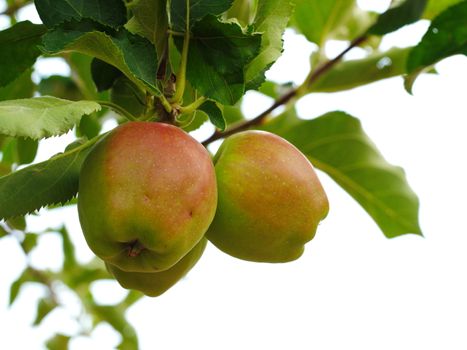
(106, 238, 207, 297)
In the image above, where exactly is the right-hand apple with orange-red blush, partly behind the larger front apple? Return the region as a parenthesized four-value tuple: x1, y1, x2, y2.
(206, 131, 329, 263)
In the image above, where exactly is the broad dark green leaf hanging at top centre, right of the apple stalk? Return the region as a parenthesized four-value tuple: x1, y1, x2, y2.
(175, 16, 261, 105)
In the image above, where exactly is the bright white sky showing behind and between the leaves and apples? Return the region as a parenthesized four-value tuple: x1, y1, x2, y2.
(0, 1, 467, 350)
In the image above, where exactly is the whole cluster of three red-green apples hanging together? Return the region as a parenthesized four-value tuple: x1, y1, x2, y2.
(78, 122, 328, 296)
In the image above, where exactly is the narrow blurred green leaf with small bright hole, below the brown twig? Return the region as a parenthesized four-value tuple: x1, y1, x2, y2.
(310, 47, 411, 92)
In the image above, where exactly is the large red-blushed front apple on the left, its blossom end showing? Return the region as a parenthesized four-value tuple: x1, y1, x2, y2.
(78, 122, 217, 272)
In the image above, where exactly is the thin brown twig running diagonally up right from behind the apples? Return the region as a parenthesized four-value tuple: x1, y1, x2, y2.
(203, 35, 368, 146)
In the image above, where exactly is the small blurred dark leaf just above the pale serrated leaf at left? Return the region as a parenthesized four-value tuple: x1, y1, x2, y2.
(38, 75, 84, 101)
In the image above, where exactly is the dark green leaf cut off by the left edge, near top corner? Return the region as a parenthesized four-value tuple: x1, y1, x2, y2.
(0, 21, 46, 87)
